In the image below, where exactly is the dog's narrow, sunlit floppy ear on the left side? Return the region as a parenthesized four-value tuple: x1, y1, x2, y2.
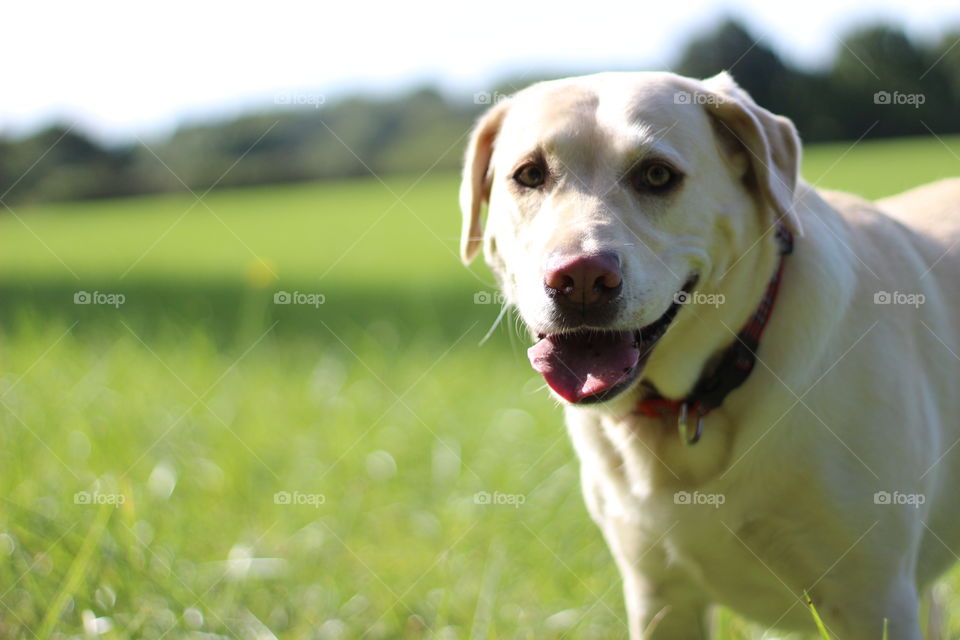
(460, 100, 509, 264)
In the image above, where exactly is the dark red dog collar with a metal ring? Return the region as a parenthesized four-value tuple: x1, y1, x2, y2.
(636, 223, 793, 444)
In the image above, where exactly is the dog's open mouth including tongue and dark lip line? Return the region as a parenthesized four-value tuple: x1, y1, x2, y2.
(527, 279, 696, 404)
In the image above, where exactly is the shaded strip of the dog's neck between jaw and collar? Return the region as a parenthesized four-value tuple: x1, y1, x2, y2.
(638, 222, 779, 399)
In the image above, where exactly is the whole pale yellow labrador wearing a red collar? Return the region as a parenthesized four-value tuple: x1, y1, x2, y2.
(460, 73, 960, 640)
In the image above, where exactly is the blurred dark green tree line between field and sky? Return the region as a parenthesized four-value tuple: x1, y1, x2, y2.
(0, 20, 960, 203)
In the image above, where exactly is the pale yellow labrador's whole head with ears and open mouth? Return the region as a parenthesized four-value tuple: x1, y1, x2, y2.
(461, 73, 799, 404)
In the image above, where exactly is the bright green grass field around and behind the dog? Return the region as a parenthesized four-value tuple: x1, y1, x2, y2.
(0, 132, 960, 639)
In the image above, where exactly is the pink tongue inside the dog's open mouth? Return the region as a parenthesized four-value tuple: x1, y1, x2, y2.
(527, 331, 640, 403)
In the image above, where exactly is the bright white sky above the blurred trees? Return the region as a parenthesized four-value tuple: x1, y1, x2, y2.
(7, 0, 960, 140)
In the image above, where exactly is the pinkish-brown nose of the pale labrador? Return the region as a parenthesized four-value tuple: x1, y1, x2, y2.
(543, 252, 623, 308)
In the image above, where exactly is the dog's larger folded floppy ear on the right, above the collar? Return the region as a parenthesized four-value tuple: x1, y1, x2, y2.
(703, 71, 802, 235)
